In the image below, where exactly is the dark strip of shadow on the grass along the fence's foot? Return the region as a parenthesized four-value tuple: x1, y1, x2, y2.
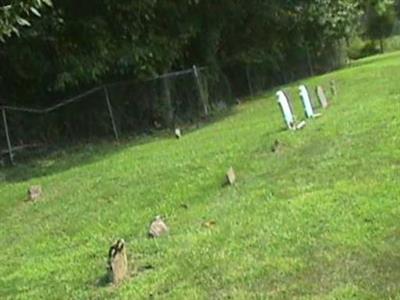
(0, 106, 241, 184)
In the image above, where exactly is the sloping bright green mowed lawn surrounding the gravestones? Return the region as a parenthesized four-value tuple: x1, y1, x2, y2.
(0, 53, 400, 299)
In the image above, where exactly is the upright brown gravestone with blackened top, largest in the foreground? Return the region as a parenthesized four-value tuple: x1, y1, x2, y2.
(108, 239, 128, 284)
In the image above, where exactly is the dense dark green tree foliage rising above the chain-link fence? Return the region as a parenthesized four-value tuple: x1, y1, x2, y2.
(0, 0, 360, 104)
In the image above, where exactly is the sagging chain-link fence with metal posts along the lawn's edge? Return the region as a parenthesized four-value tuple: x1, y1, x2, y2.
(0, 48, 342, 162)
